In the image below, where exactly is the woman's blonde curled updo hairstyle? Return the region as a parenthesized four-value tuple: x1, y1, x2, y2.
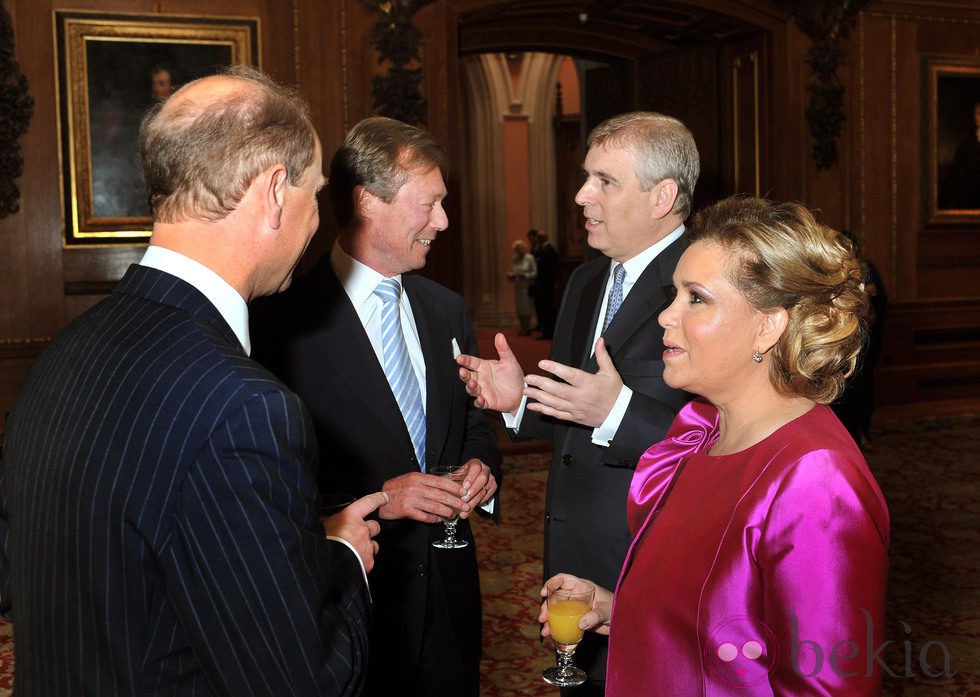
(688, 196, 869, 404)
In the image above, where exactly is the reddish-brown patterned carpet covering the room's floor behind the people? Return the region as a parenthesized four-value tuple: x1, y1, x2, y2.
(0, 416, 980, 697)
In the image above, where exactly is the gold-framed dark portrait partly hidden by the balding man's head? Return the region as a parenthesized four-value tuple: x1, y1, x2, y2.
(54, 11, 261, 246)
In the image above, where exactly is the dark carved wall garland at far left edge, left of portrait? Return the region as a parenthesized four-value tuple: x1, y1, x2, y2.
(0, 0, 34, 218)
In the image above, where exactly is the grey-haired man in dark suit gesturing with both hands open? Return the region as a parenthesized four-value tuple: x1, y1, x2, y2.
(459, 112, 700, 695)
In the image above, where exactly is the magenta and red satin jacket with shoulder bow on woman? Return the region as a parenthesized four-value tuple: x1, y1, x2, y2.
(606, 400, 889, 697)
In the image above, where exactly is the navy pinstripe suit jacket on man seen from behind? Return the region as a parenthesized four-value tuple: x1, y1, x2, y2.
(0, 266, 368, 697)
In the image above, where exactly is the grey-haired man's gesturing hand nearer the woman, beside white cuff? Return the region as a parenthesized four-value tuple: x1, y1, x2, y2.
(524, 338, 623, 428)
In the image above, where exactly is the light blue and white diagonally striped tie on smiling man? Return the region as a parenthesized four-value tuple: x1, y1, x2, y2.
(374, 278, 425, 472)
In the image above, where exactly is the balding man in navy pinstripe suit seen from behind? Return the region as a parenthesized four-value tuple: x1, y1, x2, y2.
(0, 68, 388, 697)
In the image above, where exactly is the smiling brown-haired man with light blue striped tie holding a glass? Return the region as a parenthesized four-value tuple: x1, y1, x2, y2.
(254, 117, 500, 697)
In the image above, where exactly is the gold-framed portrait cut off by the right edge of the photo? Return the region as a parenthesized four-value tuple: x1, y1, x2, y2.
(924, 57, 980, 224)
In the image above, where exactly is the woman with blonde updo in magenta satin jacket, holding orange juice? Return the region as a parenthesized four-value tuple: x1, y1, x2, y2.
(539, 197, 889, 697)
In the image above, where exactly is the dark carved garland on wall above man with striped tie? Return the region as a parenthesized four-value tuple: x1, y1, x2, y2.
(361, 0, 434, 125)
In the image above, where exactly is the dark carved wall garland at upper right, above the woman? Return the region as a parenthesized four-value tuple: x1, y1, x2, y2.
(772, 0, 874, 170)
